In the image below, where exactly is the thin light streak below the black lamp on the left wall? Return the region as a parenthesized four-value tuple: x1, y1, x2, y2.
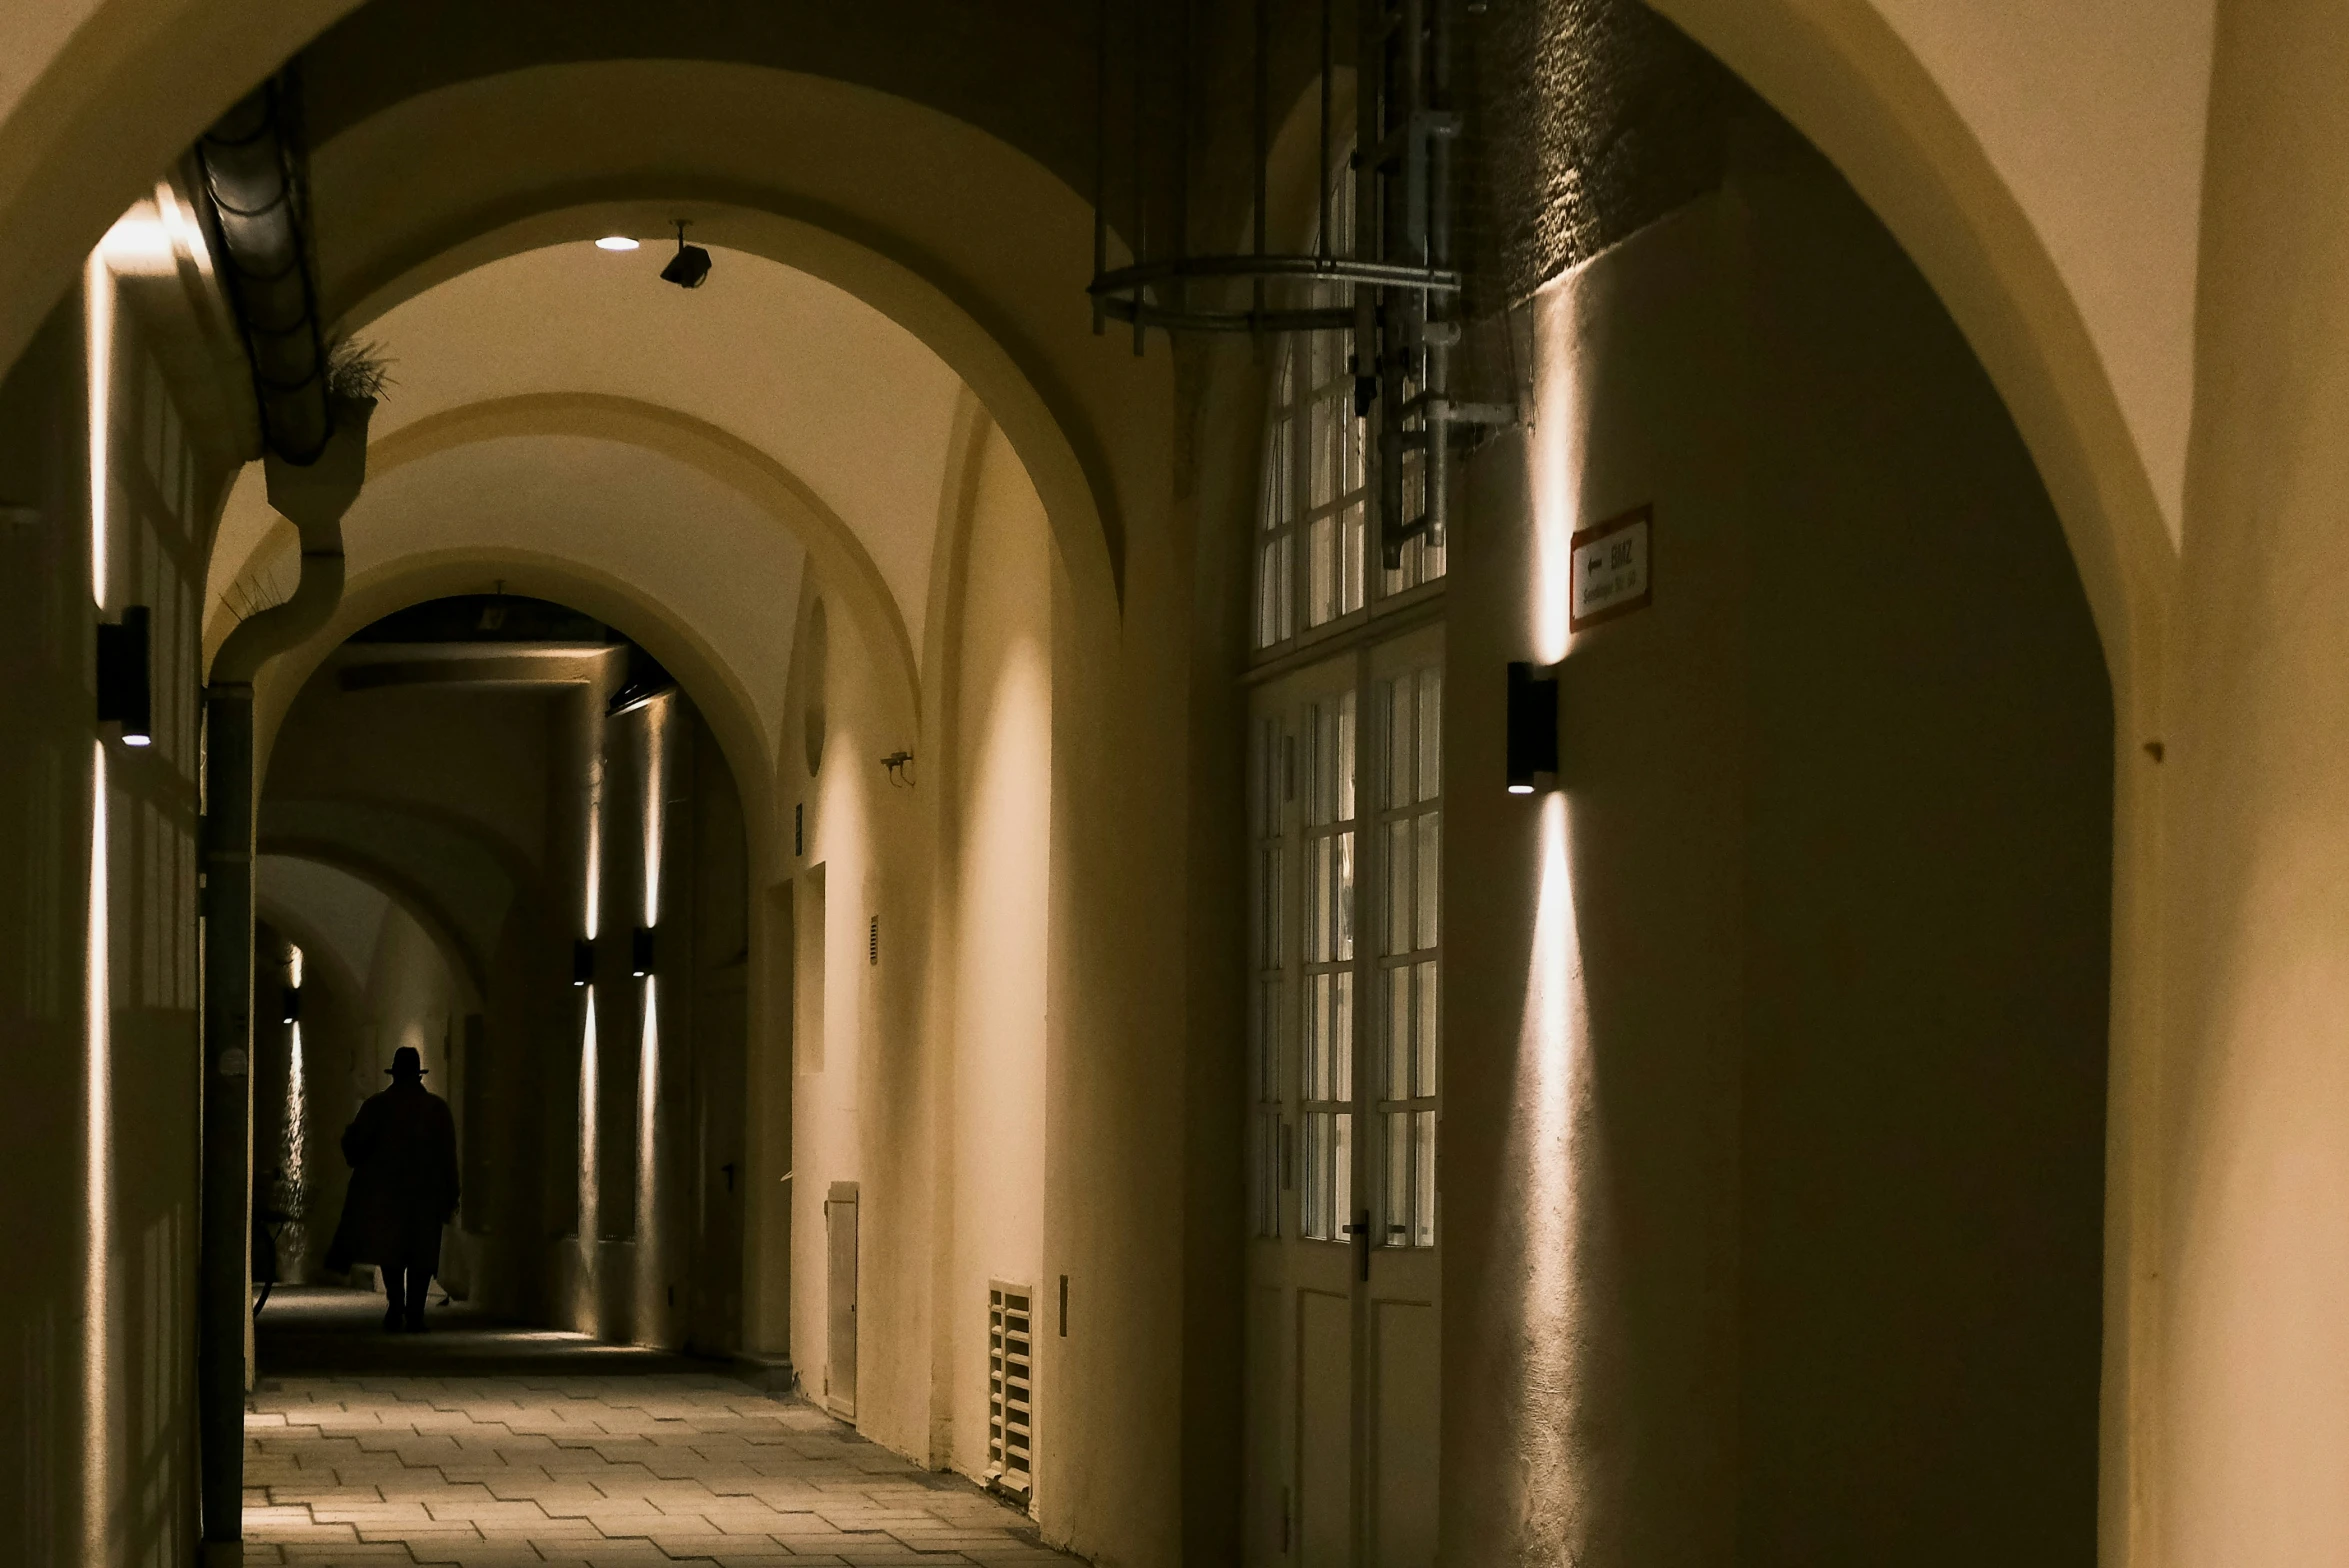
(82, 742, 115, 1563)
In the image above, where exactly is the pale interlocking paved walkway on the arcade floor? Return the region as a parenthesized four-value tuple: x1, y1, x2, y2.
(244, 1291, 1076, 1568)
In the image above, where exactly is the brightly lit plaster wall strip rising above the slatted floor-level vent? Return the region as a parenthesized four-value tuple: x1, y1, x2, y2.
(942, 430, 1055, 1476)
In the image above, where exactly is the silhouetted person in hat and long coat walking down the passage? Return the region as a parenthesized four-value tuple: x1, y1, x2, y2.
(336, 1045, 456, 1331)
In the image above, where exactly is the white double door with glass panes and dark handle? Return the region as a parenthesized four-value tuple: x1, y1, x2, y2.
(1247, 629, 1442, 1568)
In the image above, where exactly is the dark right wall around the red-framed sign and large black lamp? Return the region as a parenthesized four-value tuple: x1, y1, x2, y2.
(1442, 117, 2112, 1566)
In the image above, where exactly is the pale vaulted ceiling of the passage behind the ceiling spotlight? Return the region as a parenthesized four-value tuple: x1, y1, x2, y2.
(207, 232, 963, 769)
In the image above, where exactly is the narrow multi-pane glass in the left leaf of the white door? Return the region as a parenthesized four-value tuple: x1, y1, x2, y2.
(1299, 690, 1355, 1242)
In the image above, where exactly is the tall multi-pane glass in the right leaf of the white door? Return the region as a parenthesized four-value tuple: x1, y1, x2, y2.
(1377, 664, 1445, 1246)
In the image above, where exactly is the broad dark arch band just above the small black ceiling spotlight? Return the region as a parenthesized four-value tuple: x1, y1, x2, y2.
(312, 61, 1146, 624)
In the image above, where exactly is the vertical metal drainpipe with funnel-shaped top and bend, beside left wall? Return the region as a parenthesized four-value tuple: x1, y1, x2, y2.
(197, 399, 376, 1561)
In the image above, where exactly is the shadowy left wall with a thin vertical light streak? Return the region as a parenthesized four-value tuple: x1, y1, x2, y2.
(0, 232, 247, 1568)
